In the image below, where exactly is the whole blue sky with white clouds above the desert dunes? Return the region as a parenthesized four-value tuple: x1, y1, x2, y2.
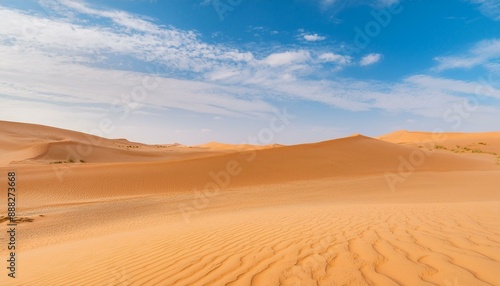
(0, 0, 500, 144)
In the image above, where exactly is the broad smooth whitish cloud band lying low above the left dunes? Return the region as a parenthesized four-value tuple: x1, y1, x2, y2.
(0, 46, 275, 117)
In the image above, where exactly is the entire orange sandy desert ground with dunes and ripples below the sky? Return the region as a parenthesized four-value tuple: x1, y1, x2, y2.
(0, 122, 500, 286)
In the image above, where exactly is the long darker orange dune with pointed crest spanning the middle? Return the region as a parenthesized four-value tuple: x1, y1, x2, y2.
(9, 132, 500, 208)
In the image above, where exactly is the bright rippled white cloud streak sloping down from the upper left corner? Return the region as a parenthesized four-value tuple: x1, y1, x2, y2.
(0, 3, 254, 72)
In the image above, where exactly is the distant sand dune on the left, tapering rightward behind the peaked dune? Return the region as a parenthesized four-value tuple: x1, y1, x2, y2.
(0, 121, 260, 166)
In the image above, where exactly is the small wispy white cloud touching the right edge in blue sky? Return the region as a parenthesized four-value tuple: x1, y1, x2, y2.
(435, 39, 500, 71)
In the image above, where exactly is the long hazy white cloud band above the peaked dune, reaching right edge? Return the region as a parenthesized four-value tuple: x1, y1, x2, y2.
(223, 66, 500, 118)
